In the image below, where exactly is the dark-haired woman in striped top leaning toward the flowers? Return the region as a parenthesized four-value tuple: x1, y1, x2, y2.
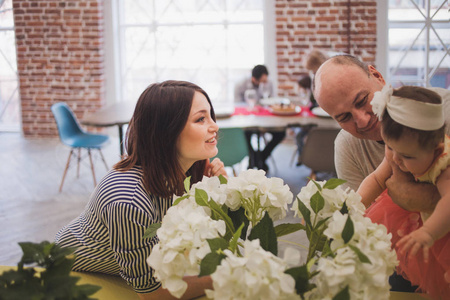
(55, 81, 226, 299)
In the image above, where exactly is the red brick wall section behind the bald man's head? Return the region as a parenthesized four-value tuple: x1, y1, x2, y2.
(275, 0, 377, 97)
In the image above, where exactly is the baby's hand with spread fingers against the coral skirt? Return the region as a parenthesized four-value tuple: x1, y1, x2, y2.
(397, 227, 434, 262)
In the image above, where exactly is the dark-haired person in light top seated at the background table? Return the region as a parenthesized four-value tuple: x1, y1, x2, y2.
(234, 65, 286, 171)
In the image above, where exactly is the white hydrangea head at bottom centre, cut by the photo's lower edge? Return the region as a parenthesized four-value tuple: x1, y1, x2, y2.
(206, 240, 300, 300)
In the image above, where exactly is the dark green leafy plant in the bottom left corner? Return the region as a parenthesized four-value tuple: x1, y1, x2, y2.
(0, 241, 100, 300)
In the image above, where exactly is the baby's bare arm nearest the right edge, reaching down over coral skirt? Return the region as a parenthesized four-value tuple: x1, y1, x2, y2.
(397, 168, 450, 261)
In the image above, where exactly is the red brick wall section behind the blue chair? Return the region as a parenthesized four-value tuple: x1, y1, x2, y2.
(13, 0, 104, 137)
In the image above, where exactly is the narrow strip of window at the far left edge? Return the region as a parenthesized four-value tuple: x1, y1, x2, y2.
(0, 0, 20, 131)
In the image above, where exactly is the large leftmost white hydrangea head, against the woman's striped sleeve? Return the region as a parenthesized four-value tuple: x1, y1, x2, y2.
(147, 199, 225, 298)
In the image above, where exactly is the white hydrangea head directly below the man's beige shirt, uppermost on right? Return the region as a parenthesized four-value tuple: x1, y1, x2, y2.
(292, 180, 365, 221)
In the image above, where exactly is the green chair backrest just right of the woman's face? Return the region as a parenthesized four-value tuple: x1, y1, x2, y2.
(217, 128, 248, 167)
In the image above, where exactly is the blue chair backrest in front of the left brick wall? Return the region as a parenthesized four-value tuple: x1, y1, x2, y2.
(52, 102, 83, 143)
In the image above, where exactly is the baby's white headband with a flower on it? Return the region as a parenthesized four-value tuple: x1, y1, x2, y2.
(370, 84, 444, 131)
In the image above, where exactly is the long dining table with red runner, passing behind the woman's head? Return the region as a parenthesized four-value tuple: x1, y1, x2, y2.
(80, 101, 339, 157)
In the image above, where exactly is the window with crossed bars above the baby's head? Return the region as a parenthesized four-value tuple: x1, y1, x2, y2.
(388, 0, 450, 88)
